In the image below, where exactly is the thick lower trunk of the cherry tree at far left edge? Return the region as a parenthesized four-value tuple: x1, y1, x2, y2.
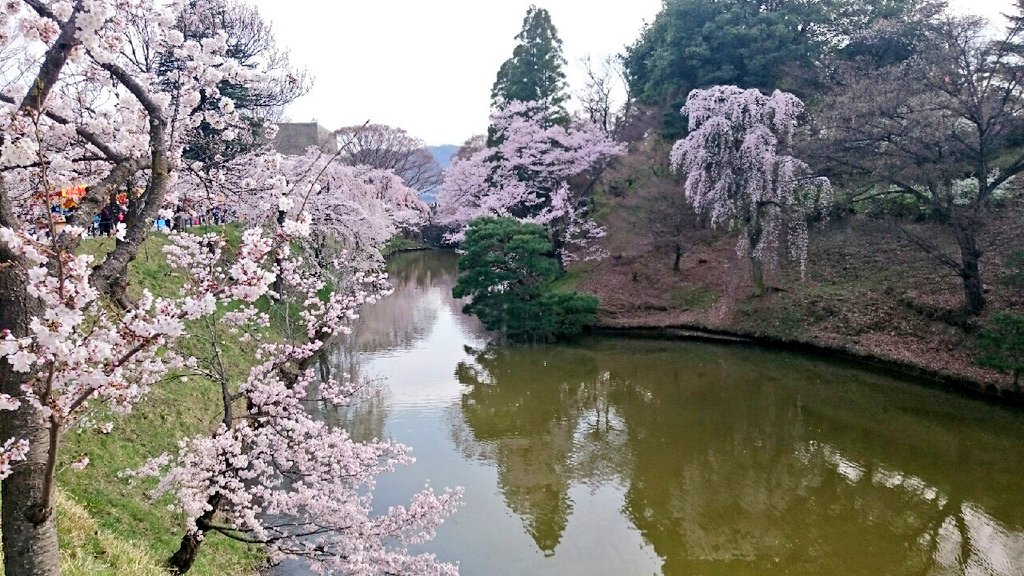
(0, 257, 60, 576)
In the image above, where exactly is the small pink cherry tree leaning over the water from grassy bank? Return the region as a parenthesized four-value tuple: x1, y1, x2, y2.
(127, 218, 460, 574)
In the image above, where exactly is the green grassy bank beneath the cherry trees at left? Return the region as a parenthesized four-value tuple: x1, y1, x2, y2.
(0, 231, 264, 576)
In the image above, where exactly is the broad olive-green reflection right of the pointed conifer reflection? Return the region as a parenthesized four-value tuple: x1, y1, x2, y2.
(608, 344, 1024, 575)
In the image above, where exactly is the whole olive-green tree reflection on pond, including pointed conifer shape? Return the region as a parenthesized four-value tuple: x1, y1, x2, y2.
(453, 341, 1024, 576)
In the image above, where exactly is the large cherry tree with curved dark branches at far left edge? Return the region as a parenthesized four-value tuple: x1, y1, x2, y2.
(0, 0, 247, 575)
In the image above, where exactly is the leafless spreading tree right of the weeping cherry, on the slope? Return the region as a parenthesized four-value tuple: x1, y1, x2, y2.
(817, 10, 1024, 315)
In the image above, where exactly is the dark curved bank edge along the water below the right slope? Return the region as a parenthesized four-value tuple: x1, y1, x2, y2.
(591, 324, 1024, 409)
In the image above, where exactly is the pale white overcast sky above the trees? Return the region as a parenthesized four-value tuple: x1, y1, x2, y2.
(252, 0, 1013, 145)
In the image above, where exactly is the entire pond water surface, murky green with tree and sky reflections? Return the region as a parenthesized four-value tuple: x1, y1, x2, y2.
(337, 252, 1024, 576)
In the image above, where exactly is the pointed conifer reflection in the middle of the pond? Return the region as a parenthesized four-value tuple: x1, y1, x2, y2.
(453, 346, 621, 553)
